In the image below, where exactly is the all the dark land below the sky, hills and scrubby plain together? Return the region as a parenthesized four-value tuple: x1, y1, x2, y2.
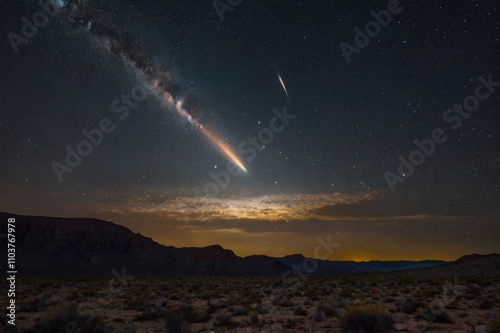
(0, 213, 500, 333)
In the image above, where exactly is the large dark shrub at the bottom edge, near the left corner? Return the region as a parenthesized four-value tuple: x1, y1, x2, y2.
(35, 303, 105, 333)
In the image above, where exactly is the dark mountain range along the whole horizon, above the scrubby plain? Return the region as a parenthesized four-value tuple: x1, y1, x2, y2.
(0, 213, 500, 276)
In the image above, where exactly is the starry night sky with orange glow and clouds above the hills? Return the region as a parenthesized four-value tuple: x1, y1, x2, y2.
(0, 0, 500, 260)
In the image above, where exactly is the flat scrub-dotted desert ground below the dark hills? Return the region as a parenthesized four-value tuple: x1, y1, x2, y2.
(1, 273, 500, 333)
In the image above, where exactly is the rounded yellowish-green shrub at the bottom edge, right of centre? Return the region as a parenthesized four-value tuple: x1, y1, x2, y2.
(340, 304, 391, 333)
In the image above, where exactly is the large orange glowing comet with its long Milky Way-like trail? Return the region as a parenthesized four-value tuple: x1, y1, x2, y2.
(56, 0, 247, 173)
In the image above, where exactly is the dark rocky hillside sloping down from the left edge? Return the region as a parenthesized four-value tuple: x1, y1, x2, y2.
(0, 213, 288, 276)
